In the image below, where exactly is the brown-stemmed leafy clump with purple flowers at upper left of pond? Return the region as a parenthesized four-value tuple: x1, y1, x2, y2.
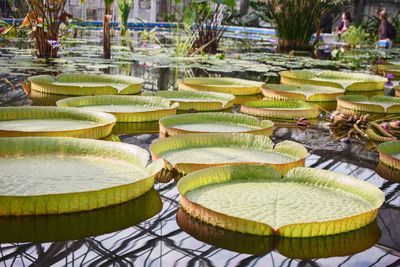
(19, 0, 71, 58)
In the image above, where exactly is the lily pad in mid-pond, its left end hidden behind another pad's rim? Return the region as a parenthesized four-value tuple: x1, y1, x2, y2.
(154, 91, 235, 111)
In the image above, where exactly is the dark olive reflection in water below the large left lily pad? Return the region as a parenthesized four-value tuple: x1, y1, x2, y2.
(0, 189, 162, 243)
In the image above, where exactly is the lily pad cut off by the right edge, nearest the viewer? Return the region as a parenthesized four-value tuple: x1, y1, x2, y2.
(378, 141, 400, 173)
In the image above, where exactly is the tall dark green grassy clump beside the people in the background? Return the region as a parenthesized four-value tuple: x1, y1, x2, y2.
(263, 0, 351, 52)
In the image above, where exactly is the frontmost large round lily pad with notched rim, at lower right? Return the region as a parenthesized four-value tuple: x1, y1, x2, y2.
(178, 165, 385, 237)
